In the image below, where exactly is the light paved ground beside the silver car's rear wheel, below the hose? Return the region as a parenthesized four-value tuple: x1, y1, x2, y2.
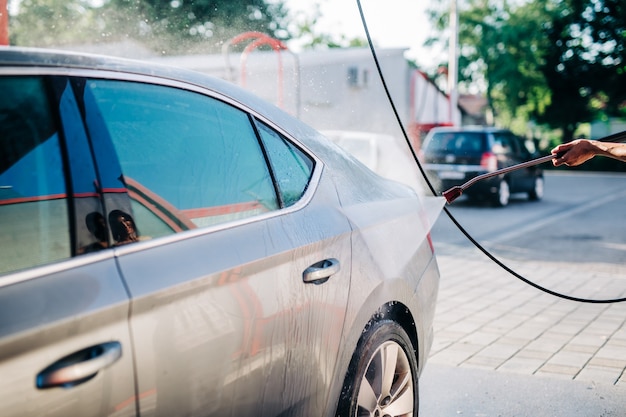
(420, 243, 626, 417)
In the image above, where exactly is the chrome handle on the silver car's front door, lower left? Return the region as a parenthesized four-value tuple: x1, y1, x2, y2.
(36, 342, 122, 389)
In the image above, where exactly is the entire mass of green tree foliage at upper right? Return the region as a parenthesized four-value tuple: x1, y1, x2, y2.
(432, 0, 626, 140)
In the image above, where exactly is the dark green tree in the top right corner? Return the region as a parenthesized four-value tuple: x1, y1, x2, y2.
(538, 0, 626, 141)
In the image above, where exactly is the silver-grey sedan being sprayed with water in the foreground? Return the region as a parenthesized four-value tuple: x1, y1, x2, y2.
(0, 47, 440, 417)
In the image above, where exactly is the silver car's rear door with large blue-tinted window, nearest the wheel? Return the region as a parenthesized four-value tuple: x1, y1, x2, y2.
(76, 78, 351, 417)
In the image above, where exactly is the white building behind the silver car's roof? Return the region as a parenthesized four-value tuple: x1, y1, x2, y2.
(155, 48, 461, 146)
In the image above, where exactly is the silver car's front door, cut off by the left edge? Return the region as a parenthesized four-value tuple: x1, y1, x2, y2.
(0, 75, 136, 417)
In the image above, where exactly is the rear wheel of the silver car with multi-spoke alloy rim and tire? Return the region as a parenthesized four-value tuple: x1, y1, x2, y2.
(337, 320, 419, 417)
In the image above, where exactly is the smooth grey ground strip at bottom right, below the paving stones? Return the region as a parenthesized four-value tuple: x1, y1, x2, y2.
(420, 364, 626, 417)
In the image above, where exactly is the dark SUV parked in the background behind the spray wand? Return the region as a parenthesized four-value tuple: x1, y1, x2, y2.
(421, 127, 544, 207)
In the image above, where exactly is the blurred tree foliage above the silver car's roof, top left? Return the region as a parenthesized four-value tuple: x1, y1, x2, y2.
(10, 0, 289, 53)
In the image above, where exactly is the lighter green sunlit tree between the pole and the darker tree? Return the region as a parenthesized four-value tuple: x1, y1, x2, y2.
(429, 0, 547, 130)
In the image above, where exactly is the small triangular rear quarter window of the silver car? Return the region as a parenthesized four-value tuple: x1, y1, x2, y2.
(252, 122, 314, 207)
